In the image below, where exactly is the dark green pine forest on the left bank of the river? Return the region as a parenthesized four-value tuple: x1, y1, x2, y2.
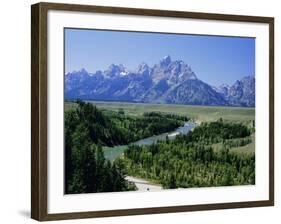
(65, 101, 187, 194)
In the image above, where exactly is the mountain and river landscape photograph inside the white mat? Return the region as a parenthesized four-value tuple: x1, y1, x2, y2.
(64, 28, 255, 194)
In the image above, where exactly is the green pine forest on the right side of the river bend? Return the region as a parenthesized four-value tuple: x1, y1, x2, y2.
(122, 119, 255, 189)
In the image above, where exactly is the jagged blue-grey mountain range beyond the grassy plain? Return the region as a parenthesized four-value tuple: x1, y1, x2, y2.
(65, 56, 255, 107)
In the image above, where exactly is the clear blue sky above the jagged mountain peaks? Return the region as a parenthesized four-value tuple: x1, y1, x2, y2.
(65, 28, 255, 85)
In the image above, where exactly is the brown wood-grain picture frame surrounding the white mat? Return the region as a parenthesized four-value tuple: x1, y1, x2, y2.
(31, 3, 274, 221)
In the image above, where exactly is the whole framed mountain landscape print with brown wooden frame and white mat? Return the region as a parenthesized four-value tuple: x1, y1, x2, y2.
(31, 3, 274, 221)
